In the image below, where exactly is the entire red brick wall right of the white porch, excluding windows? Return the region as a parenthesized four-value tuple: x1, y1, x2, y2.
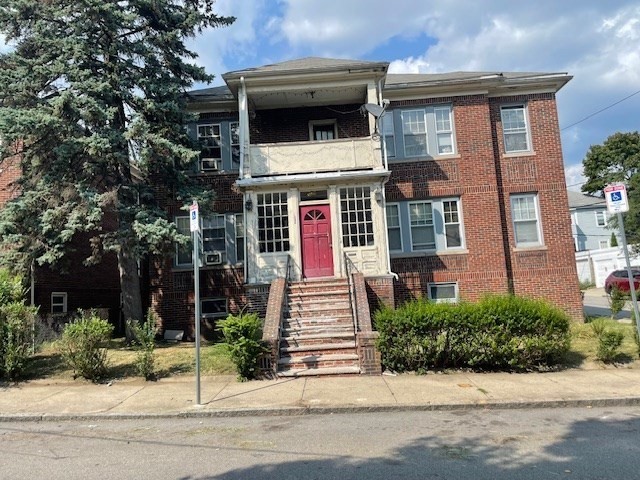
(386, 95, 582, 320)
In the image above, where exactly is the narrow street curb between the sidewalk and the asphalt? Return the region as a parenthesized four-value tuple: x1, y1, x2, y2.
(0, 397, 640, 423)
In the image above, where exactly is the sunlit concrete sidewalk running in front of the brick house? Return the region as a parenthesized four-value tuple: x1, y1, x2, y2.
(0, 365, 640, 421)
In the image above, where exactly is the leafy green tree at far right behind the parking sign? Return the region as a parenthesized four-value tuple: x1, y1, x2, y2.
(582, 132, 640, 244)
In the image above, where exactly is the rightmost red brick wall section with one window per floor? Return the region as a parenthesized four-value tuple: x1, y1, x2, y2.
(491, 94, 583, 320)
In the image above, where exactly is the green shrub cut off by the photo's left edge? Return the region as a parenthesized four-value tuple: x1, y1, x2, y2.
(0, 301, 37, 380)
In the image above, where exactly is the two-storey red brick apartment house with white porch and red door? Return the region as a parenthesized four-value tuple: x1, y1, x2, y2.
(150, 58, 582, 373)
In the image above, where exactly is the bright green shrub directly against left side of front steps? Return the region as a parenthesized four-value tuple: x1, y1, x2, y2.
(220, 313, 268, 381)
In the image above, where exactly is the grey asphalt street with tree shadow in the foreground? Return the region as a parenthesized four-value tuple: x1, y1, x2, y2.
(0, 407, 640, 480)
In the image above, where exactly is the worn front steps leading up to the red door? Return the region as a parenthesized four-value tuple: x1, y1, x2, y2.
(278, 279, 360, 377)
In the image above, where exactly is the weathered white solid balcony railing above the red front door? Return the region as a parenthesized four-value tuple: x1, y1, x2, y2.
(244, 138, 383, 177)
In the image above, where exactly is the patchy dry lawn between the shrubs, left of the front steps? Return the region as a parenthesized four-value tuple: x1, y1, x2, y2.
(24, 339, 235, 380)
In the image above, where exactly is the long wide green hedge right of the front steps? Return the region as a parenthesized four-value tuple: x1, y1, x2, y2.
(374, 296, 570, 372)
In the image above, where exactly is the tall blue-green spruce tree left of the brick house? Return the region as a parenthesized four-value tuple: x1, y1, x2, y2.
(0, 0, 234, 328)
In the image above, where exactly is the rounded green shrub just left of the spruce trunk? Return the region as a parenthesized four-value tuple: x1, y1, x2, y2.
(59, 311, 113, 381)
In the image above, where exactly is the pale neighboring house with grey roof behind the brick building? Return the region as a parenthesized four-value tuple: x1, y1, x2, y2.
(567, 191, 618, 252)
